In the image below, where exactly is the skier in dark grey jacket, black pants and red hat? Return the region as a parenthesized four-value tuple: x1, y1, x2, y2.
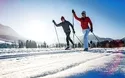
(52, 16, 75, 49)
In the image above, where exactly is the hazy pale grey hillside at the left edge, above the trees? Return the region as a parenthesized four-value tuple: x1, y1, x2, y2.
(0, 24, 25, 42)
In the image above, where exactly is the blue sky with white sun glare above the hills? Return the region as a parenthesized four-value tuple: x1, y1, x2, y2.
(0, 0, 125, 42)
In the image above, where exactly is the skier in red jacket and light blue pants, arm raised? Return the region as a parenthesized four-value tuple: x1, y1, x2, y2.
(72, 10, 93, 51)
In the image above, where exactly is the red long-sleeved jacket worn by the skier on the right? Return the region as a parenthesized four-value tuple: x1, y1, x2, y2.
(74, 13, 92, 29)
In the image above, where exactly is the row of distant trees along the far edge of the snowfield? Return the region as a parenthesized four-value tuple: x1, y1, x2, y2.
(0, 40, 125, 48)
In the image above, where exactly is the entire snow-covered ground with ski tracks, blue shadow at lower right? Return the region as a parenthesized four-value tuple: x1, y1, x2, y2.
(0, 48, 125, 78)
